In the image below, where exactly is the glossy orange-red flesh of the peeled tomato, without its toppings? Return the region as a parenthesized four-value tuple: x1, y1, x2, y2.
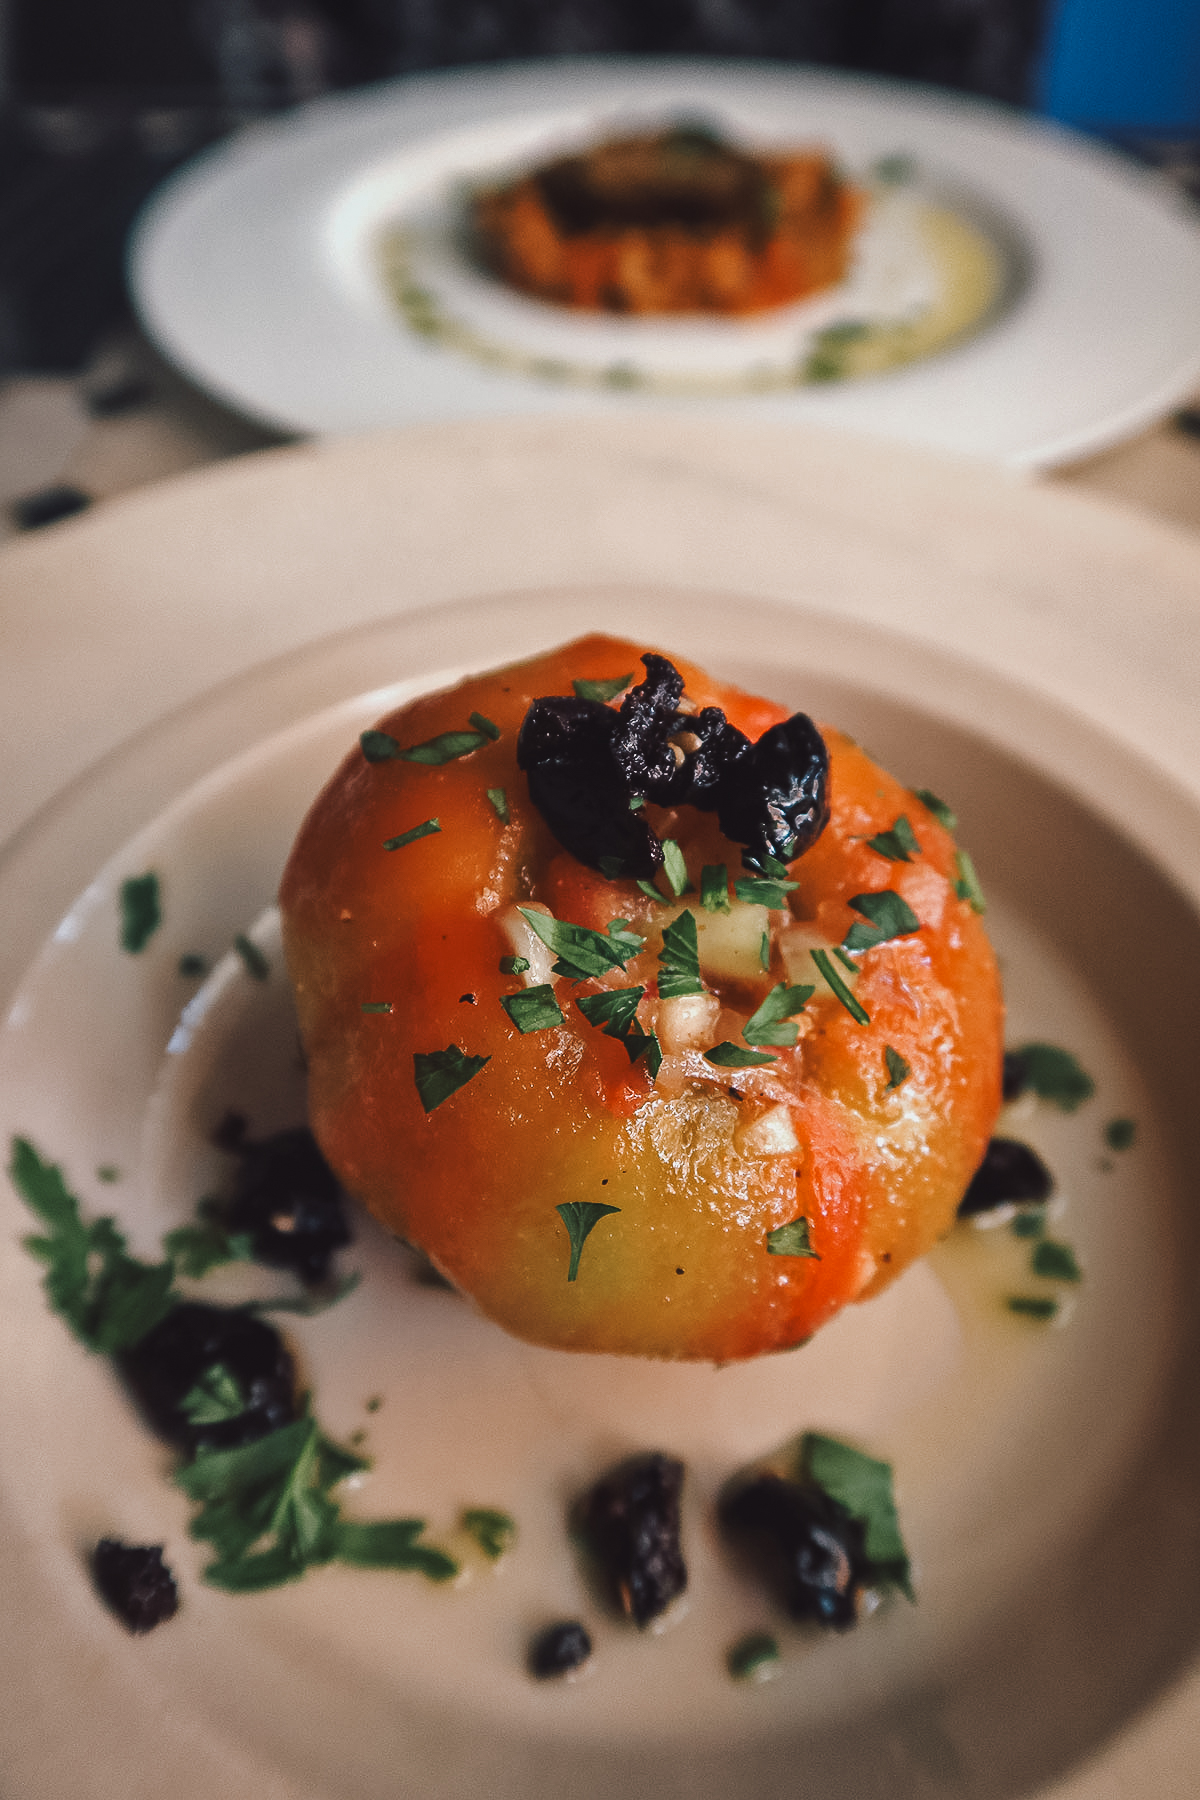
(281, 637, 1002, 1363)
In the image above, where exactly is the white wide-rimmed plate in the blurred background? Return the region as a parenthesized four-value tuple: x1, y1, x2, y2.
(131, 59, 1200, 466)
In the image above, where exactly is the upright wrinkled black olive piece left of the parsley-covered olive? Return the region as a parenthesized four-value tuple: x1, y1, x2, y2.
(578, 1451, 687, 1625)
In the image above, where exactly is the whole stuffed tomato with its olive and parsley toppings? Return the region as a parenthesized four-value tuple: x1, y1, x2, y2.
(281, 637, 1002, 1363)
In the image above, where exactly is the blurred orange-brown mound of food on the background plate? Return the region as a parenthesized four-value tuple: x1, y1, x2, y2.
(471, 124, 864, 313)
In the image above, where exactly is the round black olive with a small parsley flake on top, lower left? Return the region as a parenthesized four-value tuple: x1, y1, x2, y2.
(117, 1300, 297, 1451)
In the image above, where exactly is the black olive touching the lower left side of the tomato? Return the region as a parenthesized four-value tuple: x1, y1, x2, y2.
(225, 1125, 351, 1282)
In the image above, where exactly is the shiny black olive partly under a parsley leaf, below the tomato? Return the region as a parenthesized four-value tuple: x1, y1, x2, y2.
(718, 1472, 869, 1631)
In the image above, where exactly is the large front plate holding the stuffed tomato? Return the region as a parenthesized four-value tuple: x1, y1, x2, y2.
(0, 423, 1200, 1800)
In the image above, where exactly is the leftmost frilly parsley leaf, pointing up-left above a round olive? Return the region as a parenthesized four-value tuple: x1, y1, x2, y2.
(9, 1138, 176, 1355)
